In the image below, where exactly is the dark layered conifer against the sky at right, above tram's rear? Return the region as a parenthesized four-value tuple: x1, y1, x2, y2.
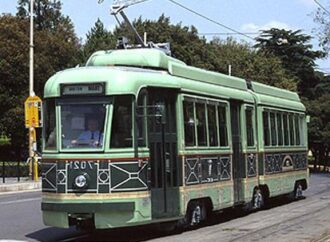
(255, 28, 324, 97)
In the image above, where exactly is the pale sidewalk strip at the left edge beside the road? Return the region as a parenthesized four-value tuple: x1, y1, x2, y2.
(0, 177, 41, 194)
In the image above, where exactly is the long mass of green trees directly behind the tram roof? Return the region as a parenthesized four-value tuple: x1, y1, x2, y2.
(114, 15, 296, 90)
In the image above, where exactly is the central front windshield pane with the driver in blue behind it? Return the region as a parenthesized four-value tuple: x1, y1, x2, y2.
(61, 104, 106, 149)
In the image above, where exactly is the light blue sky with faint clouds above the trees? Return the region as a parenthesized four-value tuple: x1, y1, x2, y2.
(0, 0, 330, 72)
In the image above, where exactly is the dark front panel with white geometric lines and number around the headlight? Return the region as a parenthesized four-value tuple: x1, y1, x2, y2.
(42, 159, 148, 194)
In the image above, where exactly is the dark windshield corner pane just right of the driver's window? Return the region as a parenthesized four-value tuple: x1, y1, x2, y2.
(110, 96, 133, 148)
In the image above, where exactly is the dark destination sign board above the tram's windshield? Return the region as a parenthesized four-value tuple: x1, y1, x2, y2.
(61, 83, 105, 96)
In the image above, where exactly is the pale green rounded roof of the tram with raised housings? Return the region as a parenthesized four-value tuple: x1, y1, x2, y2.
(44, 49, 303, 109)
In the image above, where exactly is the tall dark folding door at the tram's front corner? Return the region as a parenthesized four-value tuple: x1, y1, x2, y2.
(148, 89, 179, 218)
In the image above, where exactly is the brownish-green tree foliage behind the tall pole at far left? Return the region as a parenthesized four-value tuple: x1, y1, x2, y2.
(0, 0, 80, 159)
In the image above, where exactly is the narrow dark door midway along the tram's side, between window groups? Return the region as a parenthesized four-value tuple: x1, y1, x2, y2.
(230, 101, 244, 204)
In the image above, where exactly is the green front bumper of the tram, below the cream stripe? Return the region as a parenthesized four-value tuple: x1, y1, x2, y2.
(41, 202, 138, 229)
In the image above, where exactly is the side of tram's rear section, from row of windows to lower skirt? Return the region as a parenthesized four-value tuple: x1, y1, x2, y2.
(260, 108, 308, 196)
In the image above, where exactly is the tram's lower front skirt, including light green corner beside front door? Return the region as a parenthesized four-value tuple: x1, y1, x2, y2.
(41, 199, 151, 229)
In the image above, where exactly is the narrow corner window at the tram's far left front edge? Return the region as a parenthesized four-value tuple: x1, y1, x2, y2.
(44, 100, 57, 150)
